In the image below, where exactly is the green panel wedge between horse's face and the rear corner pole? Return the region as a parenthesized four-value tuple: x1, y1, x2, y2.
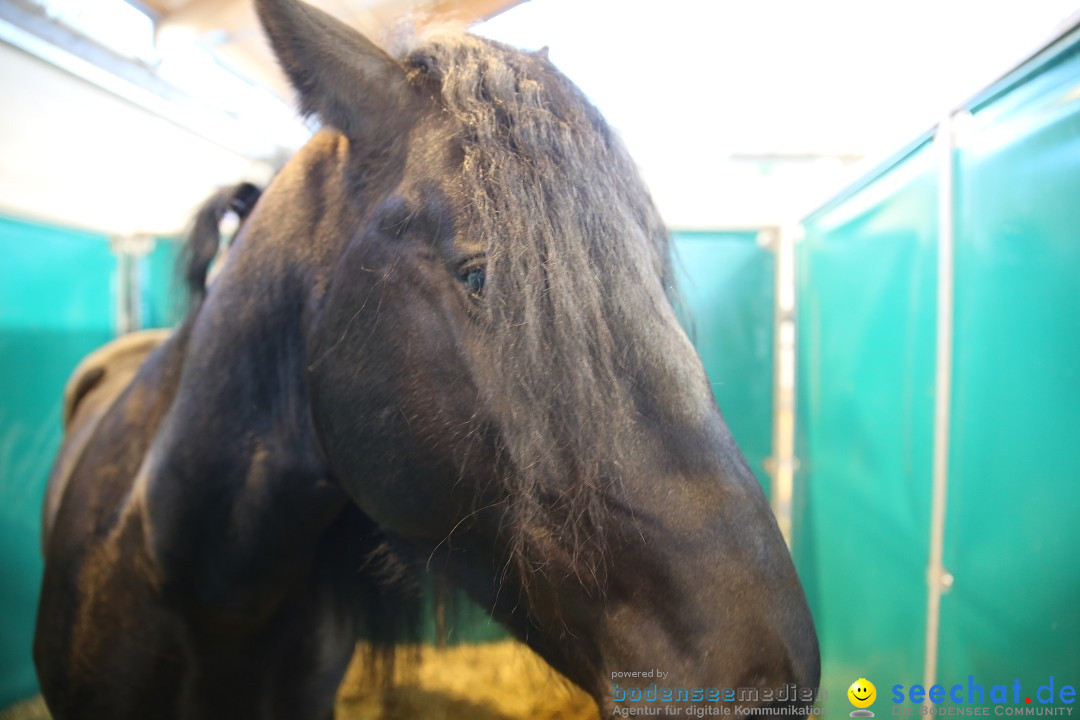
(673, 231, 775, 493)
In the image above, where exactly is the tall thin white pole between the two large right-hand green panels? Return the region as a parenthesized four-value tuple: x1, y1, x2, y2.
(922, 116, 956, 699)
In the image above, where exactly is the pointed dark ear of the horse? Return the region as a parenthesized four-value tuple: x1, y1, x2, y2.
(255, 0, 408, 139)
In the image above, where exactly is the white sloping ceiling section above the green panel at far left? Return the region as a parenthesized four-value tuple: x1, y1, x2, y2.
(0, 43, 272, 233)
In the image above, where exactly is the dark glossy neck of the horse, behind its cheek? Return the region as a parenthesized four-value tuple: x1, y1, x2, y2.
(136, 142, 371, 607)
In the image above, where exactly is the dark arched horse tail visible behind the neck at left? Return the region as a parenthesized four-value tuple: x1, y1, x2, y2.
(177, 182, 262, 305)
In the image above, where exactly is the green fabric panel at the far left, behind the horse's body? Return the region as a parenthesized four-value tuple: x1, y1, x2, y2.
(0, 218, 117, 707)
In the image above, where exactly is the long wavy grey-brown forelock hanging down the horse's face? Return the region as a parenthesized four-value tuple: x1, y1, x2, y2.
(403, 30, 674, 604)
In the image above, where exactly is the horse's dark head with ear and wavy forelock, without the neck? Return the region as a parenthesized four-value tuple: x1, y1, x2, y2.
(243, 0, 819, 709)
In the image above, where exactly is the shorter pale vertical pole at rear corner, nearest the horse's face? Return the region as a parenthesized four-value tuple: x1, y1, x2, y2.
(758, 222, 799, 548)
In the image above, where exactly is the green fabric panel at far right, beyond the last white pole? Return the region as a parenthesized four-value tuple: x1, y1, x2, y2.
(940, 38, 1080, 703)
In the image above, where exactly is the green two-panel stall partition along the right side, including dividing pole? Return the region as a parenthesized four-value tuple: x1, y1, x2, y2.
(794, 21, 1080, 715)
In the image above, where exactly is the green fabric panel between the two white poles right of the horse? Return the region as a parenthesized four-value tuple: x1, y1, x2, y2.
(793, 146, 937, 695)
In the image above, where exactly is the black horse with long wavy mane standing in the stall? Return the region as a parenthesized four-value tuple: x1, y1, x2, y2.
(35, 0, 819, 720)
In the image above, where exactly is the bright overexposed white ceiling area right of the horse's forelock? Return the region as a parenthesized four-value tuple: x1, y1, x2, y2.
(478, 0, 1080, 227)
